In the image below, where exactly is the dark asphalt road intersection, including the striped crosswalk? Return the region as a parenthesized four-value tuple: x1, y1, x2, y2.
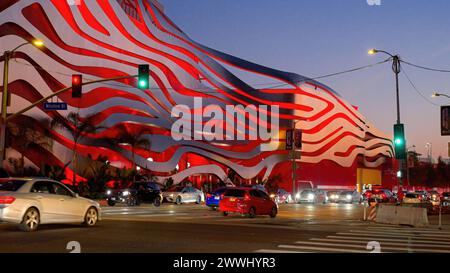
(0, 204, 450, 253)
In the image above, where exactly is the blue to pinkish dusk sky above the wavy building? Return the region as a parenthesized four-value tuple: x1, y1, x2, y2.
(160, 0, 450, 157)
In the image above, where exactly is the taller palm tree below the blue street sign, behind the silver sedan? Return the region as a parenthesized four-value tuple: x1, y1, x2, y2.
(51, 112, 102, 188)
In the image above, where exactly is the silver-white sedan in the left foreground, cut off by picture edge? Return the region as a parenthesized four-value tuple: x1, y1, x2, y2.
(0, 178, 101, 231)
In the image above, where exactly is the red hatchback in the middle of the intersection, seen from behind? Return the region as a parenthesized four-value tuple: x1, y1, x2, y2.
(219, 188, 278, 218)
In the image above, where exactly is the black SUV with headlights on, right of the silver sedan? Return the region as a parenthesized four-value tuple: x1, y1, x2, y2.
(106, 182, 162, 207)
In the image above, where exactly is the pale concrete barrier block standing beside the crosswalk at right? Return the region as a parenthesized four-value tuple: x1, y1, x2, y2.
(375, 204, 428, 227)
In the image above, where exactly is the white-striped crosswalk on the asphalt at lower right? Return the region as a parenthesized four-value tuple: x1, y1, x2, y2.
(257, 223, 450, 253)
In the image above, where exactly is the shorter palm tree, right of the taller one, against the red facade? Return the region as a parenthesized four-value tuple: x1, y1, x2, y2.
(108, 125, 151, 182)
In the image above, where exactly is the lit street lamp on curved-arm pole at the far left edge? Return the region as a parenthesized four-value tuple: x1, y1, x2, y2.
(0, 40, 44, 168)
